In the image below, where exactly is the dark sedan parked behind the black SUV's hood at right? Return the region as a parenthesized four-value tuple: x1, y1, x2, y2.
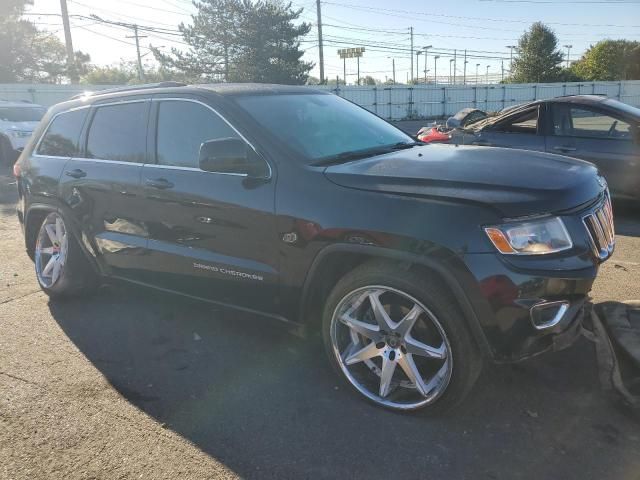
(451, 95, 640, 202)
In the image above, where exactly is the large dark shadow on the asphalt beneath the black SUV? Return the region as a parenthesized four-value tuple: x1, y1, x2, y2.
(49, 285, 640, 479)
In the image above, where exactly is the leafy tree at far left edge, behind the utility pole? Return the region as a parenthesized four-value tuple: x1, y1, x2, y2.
(0, 0, 90, 83)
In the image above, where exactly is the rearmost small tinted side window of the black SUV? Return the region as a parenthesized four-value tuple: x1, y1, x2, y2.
(36, 108, 89, 157)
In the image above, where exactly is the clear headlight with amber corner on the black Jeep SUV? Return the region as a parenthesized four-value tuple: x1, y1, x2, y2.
(484, 217, 573, 255)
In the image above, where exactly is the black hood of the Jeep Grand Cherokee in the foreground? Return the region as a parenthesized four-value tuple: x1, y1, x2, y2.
(325, 145, 606, 217)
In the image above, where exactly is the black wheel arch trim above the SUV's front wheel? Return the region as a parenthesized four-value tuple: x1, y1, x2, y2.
(298, 244, 493, 358)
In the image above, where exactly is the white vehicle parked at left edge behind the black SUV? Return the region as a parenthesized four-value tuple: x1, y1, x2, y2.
(0, 100, 47, 165)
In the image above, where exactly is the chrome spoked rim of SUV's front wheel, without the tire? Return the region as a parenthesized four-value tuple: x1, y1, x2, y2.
(331, 286, 453, 410)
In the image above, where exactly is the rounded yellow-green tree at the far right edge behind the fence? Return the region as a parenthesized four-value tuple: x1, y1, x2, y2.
(571, 40, 640, 81)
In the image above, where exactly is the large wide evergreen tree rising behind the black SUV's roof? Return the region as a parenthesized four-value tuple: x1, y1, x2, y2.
(153, 0, 313, 84)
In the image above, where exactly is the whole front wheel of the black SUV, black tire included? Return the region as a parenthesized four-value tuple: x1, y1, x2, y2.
(322, 262, 482, 413)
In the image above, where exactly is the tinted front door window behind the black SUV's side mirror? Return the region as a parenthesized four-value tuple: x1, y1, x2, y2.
(156, 100, 238, 168)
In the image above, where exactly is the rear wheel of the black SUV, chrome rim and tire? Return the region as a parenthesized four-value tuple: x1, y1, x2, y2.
(34, 212, 97, 297)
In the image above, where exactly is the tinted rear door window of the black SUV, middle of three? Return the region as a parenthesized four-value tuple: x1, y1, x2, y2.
(86, 102, 148, 163)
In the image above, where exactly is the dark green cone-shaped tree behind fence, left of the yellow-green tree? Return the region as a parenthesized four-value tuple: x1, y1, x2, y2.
(508, 22, 563, 83)
